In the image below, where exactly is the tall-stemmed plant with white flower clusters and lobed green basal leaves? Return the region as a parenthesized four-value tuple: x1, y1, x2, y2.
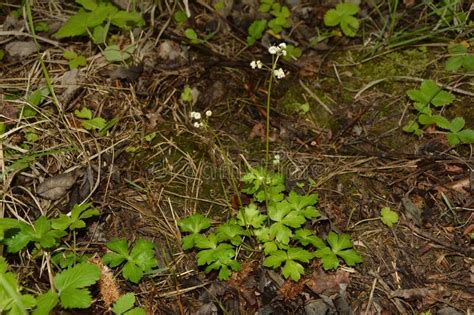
(178, 43, 362, 281)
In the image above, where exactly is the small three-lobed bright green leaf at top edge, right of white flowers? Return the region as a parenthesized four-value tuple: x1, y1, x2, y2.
(324, 3, 360, 37)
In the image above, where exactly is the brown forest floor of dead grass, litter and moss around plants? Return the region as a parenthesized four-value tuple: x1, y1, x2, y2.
(0, 0, 474, 314)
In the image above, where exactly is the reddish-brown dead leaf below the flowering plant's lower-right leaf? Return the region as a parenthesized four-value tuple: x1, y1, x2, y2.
(306, 269, 349, 296)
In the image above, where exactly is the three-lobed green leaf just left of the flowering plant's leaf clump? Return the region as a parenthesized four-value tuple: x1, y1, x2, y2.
(103, 239, 158, 283)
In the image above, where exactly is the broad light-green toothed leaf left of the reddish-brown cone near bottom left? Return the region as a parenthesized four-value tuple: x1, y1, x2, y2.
(54, 263, 100, 308)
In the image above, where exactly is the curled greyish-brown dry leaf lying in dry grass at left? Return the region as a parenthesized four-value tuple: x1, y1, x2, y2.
(36, 171, 81, 200)
